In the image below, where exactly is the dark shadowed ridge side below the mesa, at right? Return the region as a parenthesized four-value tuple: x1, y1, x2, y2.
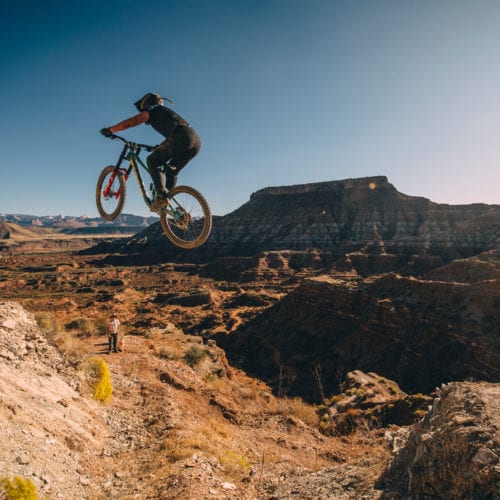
(218, 273, 500, 399)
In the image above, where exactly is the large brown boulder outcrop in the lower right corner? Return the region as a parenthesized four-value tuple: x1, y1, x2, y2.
(379, 382, 500, 499)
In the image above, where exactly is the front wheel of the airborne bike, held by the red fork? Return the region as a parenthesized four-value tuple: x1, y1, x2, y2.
(95, 165, 126, 220)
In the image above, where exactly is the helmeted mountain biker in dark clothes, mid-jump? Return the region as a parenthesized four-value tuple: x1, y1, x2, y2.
(101, 92, 201, 211)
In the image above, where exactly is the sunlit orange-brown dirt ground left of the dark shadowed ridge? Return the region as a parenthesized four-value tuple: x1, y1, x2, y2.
(0, 253, 389, 499)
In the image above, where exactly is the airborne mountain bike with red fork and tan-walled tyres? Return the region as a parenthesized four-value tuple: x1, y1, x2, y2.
(96, 134, 212, 248)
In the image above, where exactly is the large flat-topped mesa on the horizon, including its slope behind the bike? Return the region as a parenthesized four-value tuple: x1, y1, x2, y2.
(96, 176, 500, 275)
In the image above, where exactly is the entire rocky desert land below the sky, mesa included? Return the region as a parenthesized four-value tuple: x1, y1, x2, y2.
(0, 178, 500, 499)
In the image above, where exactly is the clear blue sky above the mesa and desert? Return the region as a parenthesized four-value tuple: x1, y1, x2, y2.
(0, 0, 500, 216)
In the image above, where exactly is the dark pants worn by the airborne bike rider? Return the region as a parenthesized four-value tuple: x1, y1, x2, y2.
(147, 127, 201, 195)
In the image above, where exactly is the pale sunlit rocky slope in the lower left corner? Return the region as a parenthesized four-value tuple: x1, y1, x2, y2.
(0, 302, 107, 498)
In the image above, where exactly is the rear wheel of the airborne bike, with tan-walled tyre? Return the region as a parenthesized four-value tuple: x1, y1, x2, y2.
(160, 186, 212, 248)
